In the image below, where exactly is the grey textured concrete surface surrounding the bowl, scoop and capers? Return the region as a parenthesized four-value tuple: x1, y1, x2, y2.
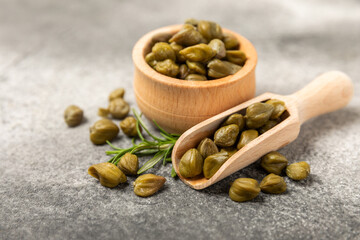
(0, 0, 360, 239)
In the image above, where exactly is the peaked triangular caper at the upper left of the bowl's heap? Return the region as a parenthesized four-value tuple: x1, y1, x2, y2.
(169, 24, 206, 46)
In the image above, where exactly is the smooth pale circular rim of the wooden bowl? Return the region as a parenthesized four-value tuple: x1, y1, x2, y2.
(132, 24, 257, 88)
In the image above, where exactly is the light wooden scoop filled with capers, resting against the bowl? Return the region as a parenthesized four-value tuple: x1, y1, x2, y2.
(172, 71, 353, 189)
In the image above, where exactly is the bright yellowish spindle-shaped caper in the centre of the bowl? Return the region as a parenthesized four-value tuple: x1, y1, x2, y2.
(180, 43, 216, 62)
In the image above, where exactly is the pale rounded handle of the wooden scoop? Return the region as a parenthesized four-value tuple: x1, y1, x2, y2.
(291, 71, 354, 123)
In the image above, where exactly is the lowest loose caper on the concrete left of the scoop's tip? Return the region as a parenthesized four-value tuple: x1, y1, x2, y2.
(134, 173, 166, 197)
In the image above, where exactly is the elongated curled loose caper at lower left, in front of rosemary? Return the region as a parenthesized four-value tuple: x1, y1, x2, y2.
(88, 162, 127, 188)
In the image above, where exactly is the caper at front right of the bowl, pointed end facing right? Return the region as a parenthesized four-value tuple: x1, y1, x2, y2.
(207, 59, 241, 78)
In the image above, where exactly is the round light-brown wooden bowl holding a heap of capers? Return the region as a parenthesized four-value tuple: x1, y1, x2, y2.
(132, 25, 257, 133)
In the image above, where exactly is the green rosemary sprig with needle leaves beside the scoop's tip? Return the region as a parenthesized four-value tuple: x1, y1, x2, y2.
(106, 109, 180, 177)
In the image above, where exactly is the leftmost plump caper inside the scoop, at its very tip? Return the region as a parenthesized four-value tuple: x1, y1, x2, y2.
(179, 148, 204, 178)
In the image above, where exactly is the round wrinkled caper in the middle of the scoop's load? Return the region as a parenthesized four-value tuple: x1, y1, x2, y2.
(214, 124, 240, 147)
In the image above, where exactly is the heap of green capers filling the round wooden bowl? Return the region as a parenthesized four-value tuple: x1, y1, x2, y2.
(145, 19, 246, 81)
